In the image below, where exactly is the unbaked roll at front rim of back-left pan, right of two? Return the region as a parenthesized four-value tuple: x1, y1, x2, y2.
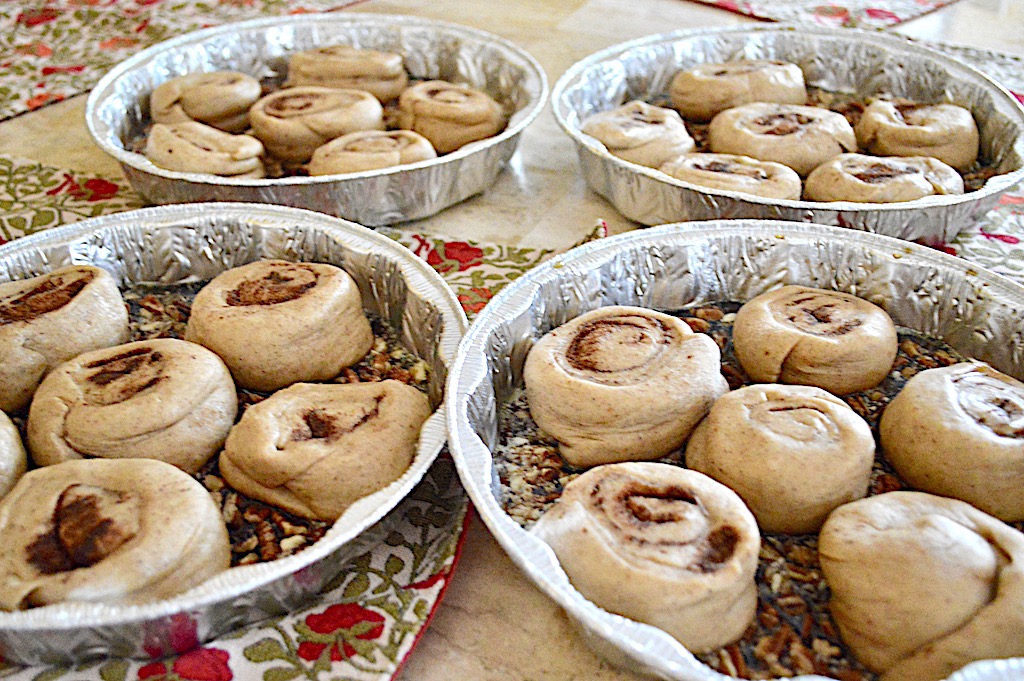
(309, 130, 437, 175)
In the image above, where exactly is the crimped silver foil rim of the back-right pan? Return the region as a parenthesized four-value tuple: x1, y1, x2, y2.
(551, 25, 1024, 213)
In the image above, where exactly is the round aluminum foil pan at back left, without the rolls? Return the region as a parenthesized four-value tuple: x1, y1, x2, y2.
(85, 13, 548, 226)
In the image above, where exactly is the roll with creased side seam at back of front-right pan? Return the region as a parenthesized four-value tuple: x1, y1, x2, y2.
(732, 286, 897, 395)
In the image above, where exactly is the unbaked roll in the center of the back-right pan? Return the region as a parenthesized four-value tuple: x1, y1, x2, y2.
(708, 102, 857, 176)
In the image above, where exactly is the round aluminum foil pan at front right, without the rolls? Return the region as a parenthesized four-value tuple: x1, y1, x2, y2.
(446, 220, 1024, 681)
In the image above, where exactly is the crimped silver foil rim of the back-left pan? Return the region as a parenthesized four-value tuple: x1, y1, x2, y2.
(85, 12, 548, 187)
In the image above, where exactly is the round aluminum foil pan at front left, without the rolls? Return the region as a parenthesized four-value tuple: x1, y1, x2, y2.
(0, 204, 466, 665)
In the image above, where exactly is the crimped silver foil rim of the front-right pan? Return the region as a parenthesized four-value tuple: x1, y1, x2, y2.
(445, 219, 1024, 681)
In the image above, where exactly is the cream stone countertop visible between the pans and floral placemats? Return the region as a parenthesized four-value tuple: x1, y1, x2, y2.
(0, 0, 1024, 681)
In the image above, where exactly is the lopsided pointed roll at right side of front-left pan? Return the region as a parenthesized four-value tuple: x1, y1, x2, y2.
(220, 380, 430, 521)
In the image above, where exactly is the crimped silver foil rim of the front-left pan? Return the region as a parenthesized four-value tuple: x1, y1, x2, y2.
(0, 203, 468, 631)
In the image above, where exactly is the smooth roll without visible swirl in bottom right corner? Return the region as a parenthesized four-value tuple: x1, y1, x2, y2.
(818, 492, 1024, 681)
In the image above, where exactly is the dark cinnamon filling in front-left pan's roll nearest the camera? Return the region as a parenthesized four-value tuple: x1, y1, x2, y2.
(26, 484, 139, 574)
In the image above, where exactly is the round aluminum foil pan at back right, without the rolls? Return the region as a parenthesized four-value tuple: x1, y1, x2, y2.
(552, 26, 1024, 245)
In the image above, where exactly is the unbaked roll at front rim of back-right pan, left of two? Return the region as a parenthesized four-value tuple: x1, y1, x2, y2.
(658, 154, 801, 200)
